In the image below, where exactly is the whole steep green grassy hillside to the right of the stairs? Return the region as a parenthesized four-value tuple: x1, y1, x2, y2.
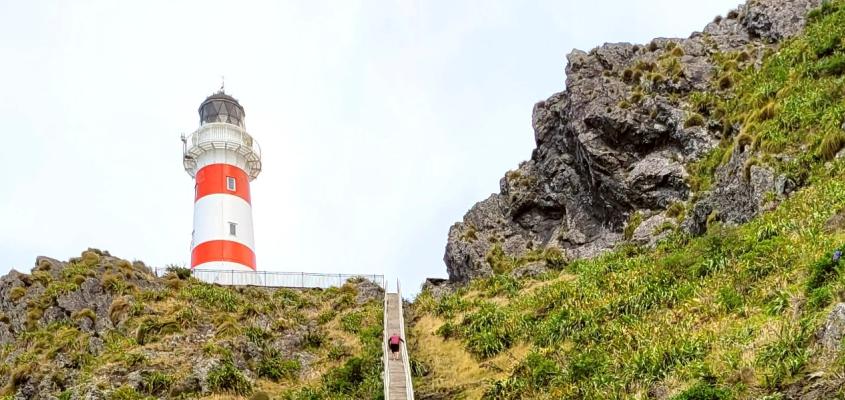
(409, 1, 845, 399)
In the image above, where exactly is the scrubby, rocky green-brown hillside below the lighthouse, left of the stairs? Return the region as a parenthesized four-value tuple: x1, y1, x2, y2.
(0, 255, 383, 399)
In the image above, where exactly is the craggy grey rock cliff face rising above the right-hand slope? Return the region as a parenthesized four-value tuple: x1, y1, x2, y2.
(444, 0, 820, 283)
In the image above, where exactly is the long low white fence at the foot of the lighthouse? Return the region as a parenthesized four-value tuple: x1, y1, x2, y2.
(154, 268, 384, 289)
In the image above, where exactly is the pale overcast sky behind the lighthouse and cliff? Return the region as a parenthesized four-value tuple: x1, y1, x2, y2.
(0, 0, 738, 292)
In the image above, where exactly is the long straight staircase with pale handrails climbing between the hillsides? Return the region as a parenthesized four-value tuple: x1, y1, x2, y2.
(383, 281, 414, 400)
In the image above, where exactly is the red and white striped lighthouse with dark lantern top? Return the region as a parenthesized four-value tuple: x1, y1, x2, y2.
(182, 88, 261, 271)
